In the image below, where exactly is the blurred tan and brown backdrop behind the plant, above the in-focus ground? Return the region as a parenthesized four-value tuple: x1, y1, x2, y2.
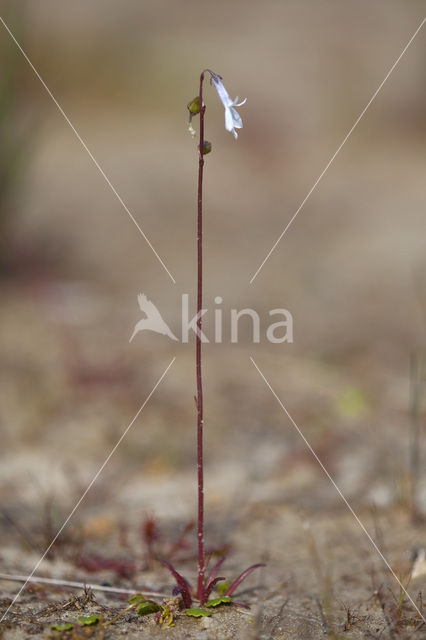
(0, 0, 426, 604)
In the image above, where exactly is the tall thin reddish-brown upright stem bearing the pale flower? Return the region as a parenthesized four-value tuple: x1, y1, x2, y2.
(196, 71, 206, 604)
